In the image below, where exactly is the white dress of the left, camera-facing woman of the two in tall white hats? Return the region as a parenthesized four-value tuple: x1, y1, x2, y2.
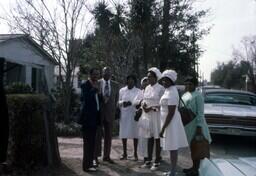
(139, 83, 164, 139)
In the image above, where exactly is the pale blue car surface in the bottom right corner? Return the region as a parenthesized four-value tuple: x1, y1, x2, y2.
(199, 157, 256, 176)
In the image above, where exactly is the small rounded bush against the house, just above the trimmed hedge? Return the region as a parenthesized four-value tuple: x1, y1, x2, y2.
(6, 82, 32, 94)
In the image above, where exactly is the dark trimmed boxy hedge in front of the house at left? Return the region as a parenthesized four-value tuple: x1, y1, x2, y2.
(7, 94, 48, 168)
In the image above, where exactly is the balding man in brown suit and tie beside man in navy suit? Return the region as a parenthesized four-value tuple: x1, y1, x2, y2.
(96, 67, 119, 164)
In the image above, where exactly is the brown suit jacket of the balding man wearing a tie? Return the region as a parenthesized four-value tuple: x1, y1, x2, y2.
(99, 79, 119, 122)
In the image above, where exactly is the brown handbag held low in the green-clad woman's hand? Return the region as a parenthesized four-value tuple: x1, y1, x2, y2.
(190, 134, 210, 160)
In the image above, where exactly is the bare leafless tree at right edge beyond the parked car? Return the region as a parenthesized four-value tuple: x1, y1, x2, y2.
(233, 35, 256, 92)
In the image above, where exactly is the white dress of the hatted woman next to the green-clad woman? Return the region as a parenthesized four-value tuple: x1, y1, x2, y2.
(160, 86, 188, 151)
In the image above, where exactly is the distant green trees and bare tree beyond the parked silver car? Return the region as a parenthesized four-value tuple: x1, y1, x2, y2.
(211, 36, 256, 92)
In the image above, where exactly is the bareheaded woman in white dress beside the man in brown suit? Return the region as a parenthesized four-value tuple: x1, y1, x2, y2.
(119, 75, 141, 160)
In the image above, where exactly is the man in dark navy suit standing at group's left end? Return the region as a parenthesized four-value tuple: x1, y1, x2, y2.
(80, 68, 101, 172)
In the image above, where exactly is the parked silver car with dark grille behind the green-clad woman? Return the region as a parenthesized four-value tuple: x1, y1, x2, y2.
(204, 89, 256, 136)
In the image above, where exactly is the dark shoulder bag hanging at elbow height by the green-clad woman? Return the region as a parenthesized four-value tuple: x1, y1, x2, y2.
(179, 98, 196, 126)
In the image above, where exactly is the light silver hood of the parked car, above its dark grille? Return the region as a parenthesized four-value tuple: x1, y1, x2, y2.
(204, 104, 256, 117)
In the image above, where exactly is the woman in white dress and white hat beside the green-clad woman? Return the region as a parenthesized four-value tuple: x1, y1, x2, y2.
(160, 70, 188, 176)
